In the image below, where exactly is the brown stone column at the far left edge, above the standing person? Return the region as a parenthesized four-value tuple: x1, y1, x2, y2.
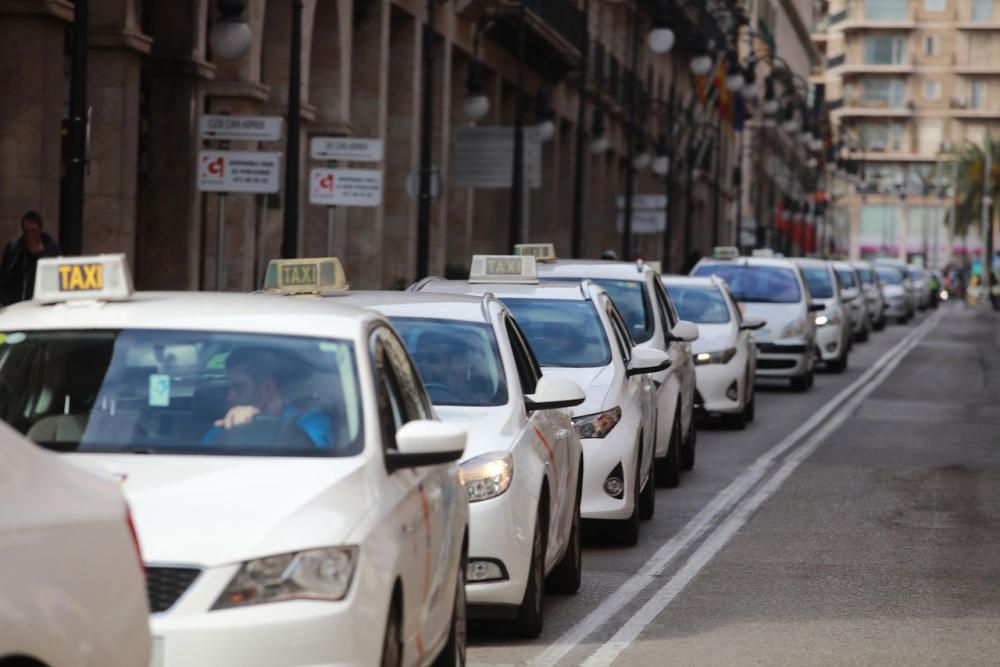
(0, 0, 73, 237)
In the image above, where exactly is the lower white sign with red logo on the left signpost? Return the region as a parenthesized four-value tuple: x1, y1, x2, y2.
(198, 151, 281, 194)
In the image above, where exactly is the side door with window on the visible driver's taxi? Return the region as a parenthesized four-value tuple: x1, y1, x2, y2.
(371, 326, 461, 656)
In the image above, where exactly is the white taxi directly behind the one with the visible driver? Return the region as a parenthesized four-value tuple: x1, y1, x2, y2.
(334, 292, 584, 637)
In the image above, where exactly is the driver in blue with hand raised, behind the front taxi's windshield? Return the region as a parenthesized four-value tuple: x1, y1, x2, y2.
(202, 348, 334, 448)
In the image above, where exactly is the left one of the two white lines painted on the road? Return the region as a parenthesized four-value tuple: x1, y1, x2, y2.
(527, 313, 940, 667)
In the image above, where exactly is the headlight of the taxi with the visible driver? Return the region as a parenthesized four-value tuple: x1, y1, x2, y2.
(212, 546, 358, 610)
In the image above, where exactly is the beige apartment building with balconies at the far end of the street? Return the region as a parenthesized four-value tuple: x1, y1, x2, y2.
(813, 0, 1000, 265)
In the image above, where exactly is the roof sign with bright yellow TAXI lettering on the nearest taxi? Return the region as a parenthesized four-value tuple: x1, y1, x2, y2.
(33, 253, 135, 303)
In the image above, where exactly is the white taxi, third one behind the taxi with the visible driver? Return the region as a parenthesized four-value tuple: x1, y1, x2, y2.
(538, 259, 698, 487)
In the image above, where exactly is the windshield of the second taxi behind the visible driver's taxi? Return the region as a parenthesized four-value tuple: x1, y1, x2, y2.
(503, 299, 611, 368)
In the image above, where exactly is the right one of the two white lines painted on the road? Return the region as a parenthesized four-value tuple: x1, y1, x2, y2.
(583, 313, 940, 667)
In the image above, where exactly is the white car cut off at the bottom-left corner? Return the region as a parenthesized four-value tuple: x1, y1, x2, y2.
(0, 420, 150, 667)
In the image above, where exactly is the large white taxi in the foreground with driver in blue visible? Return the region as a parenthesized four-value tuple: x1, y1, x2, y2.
(0, 255, 468, 667)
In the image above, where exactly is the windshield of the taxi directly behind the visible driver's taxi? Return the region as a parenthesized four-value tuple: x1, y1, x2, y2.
(391, 317, 507, 406)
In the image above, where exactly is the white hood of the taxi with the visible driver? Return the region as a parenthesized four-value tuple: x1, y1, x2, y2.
(69, 454, 376, 567)
